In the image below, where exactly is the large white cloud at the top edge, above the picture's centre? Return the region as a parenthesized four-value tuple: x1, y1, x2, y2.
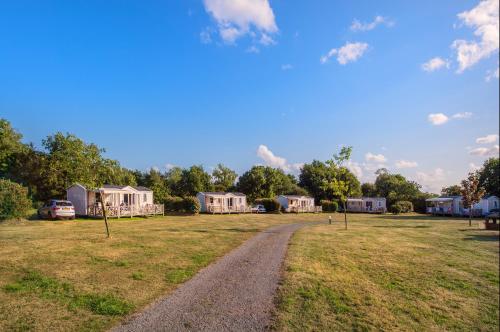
(203, 0, 278, 45)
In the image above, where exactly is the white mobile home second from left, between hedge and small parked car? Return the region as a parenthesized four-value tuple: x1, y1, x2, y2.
(196, 192, 251, 213)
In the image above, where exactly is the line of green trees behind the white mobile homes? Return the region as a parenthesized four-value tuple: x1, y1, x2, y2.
(0, 119, 499, 218)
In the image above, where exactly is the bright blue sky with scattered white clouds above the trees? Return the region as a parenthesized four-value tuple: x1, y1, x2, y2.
(0, 0, 499, 191)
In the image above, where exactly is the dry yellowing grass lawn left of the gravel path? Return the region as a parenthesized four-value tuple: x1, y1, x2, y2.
(0, 215, 325, 331)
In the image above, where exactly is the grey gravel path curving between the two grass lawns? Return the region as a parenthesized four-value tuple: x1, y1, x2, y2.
(113, 224, 305, 331)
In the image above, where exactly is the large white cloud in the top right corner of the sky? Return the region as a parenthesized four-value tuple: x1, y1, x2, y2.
(452, 0, 499, 73)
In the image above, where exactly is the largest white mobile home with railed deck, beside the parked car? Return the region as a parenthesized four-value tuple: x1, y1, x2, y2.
(66, 183, 163, 218)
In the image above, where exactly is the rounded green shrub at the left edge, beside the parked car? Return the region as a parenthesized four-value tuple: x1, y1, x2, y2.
(0, 179, 31, 220)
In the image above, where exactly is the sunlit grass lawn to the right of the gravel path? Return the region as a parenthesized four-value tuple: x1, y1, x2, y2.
(274, 214, 499, 331)
